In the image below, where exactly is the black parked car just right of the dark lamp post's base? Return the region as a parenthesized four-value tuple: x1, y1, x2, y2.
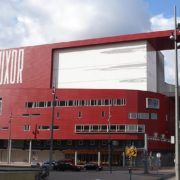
(56, 161, 81, 171)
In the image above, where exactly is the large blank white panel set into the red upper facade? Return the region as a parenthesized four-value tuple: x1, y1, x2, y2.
(53, 41, 147, 90)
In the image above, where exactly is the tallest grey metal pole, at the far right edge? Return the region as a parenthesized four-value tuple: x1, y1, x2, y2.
(174, 6, 180, 180)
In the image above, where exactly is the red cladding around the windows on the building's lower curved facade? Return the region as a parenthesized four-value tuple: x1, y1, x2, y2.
(0, 89, 174, 148)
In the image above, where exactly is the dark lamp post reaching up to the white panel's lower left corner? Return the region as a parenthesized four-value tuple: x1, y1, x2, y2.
(49, 87, 56, 169)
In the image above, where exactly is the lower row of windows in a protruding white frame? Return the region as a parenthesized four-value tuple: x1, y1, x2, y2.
(75, 124, 145, 133)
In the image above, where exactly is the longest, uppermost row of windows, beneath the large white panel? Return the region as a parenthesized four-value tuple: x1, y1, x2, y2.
(25, 98, 126, 108)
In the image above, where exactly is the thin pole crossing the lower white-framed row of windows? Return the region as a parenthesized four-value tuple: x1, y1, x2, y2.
(108, 106, 112, 174)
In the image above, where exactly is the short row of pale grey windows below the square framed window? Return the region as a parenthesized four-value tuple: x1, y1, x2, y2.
(128, 113, 158, 120)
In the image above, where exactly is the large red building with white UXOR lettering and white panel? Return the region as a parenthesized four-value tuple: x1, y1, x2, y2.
(0, 31, 179, 164)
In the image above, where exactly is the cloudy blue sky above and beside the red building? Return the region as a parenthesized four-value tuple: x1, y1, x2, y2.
(0, 0, 180, 82)
